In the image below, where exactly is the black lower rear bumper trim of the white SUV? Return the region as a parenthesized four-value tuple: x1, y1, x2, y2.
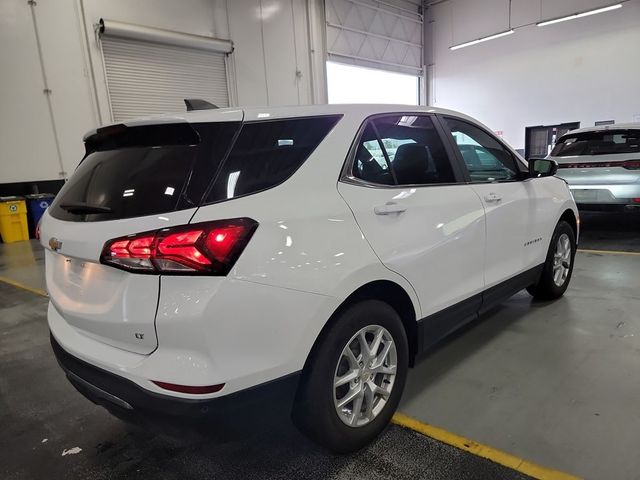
(50, 335, 300, 418)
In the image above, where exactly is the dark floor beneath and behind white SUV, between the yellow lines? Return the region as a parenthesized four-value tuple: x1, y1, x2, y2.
(0, 282, 529, 480)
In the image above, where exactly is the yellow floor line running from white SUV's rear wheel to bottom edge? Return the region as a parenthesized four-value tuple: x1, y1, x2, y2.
(391, 412, 579, 480)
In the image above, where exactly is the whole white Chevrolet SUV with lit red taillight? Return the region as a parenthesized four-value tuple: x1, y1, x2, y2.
(41, 105, 578, 452)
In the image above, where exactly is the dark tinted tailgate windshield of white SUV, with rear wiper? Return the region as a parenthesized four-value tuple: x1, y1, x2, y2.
(51, 122, 240, 222)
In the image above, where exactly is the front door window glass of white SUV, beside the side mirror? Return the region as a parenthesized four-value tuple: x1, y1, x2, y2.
(446, 118, 520, 183)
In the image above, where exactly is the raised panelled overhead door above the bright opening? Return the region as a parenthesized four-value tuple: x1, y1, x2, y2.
(325, 0, 423, 76)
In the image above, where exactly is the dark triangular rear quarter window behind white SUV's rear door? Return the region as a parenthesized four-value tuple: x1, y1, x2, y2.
(205, 115, 340, 203)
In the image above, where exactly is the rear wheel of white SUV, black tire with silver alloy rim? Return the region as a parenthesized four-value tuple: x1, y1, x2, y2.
(293, 300, 409, 453)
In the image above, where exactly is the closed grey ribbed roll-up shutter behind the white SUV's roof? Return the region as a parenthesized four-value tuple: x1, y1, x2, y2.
(101, 22, 229, 122)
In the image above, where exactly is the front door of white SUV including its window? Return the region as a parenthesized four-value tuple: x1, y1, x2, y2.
(442, 116, 543, 288)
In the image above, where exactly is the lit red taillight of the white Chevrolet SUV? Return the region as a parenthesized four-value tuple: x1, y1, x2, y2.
(100, 218, 258, 275)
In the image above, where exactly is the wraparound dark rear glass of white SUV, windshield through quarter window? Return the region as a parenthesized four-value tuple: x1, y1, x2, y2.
(50, 115, 340, 222)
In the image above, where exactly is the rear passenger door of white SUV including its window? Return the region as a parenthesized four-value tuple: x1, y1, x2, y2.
(338, 113, 485, 328)
